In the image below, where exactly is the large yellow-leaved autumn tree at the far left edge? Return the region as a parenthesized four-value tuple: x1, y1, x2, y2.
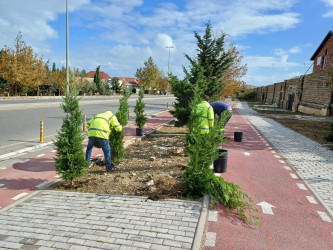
(0, 33, 47, 95)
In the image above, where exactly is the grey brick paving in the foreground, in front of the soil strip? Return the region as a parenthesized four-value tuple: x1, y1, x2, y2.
(0, 190, 202, 249)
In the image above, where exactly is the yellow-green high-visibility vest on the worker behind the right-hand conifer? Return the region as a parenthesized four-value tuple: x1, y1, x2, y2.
(196, 101, 214, 134)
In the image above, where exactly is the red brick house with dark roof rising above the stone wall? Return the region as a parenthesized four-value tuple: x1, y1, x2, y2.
(310, 30, 333, 73)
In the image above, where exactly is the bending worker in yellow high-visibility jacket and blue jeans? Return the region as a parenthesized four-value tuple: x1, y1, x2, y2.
(86, 111, 122, 172)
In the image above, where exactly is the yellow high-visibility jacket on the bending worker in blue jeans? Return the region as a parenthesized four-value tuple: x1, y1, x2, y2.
(87, 111, 122, 139)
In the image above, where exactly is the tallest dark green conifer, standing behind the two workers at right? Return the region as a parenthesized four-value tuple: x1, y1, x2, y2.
(170, 23, 233, 126)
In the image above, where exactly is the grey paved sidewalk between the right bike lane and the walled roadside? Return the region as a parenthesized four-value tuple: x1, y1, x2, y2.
(238, 102, 333, 216)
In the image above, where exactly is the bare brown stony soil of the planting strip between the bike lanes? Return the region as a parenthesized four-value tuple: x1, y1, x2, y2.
(56, 124, 188, 200)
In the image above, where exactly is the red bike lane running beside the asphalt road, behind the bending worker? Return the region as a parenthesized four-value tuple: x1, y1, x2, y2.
(0, 111, 174, 210)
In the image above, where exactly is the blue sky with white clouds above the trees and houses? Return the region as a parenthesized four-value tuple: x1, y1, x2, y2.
(0, 0, 333, 86)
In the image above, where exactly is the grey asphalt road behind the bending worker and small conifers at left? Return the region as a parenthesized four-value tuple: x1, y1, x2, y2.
(0, 95, 175, 157)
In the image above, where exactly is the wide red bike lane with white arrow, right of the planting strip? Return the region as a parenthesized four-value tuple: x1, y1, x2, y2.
(202, 110, 333, 250)
